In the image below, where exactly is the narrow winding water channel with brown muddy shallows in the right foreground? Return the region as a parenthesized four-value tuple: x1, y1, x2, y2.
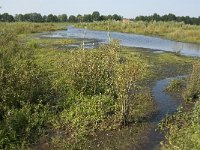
(84, 76, 185, 150)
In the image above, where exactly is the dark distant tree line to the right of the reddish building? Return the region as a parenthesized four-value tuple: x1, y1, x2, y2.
(132, 13, 200, 25)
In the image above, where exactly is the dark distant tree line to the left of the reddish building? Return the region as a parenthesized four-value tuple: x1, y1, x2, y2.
(0, 11, 123, 23)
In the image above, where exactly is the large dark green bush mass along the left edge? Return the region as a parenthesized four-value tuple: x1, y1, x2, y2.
(0, 31, 57, 149)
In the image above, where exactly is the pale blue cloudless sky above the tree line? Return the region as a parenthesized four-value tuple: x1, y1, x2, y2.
(0, 0, 200, 18)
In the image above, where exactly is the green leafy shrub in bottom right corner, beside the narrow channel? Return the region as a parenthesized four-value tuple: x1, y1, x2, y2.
(159, 102, 200, 150)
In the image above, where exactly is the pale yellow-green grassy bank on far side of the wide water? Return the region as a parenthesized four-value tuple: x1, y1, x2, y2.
(75, 21, 200, 43)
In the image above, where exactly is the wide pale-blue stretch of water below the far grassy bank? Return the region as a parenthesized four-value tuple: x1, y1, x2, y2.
(43, 27, 200, 57)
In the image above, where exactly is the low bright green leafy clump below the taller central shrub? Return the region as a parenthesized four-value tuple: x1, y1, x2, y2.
(61, 95, 117, 136)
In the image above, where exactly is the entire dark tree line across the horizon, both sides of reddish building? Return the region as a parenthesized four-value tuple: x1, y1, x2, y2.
(0, 11, 200, 25)
